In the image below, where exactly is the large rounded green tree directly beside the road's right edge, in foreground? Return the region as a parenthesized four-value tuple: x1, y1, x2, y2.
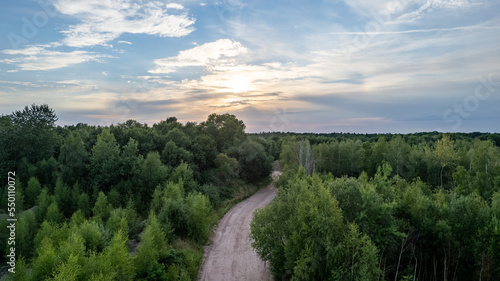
(250, 177, 352, 280)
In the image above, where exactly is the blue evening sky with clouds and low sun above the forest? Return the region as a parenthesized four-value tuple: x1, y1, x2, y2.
(0, 0, 500, 133)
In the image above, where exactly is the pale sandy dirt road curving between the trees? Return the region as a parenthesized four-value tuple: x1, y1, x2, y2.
(200, 171, 281, 281)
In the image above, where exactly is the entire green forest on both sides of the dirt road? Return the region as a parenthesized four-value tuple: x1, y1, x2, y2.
(0, 104, 500, 281)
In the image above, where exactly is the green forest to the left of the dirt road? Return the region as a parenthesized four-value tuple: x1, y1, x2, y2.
(0, 104, 273, 281)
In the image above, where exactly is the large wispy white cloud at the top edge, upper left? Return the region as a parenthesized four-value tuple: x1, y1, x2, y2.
(54, 0, 195, 47)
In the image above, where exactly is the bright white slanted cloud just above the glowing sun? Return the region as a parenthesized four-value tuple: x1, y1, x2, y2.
(149, 39, 247, 73)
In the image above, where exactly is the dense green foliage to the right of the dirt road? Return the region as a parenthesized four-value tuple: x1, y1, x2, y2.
(251, 133, 500, 280)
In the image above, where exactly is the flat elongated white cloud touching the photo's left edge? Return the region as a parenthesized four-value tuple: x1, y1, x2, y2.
(0, 46, 112, 70)
